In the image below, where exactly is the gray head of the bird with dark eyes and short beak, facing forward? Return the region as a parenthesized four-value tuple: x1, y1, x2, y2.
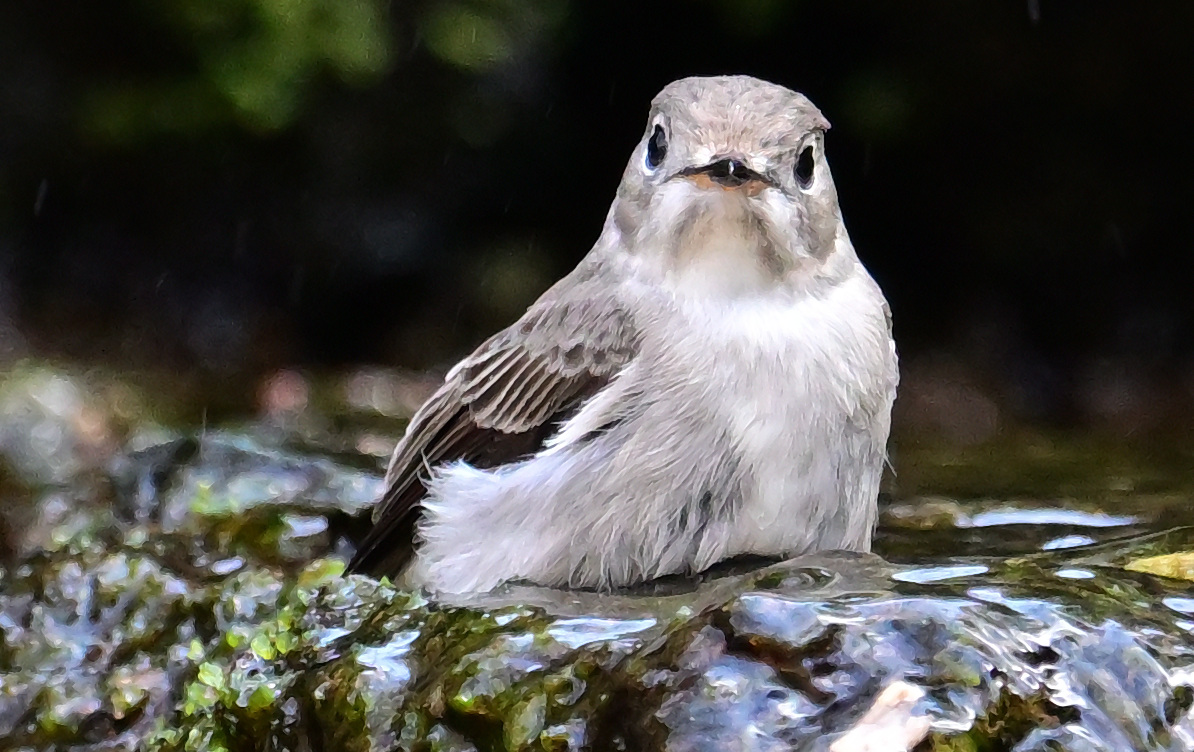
(609, 76, 853, 295)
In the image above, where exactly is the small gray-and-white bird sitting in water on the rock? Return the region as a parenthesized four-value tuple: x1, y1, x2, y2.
(349, 76, 898, 592)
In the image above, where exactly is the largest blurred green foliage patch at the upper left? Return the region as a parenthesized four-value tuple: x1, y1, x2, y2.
(82, 0, 393, 141)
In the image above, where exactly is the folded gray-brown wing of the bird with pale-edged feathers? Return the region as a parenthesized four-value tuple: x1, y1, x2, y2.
(349, 267, 639, 575)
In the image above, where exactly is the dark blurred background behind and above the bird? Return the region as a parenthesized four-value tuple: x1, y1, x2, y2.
(0, 0, 1194, 443)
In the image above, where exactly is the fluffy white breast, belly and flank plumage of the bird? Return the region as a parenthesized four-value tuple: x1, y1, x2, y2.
(418, 241, 896, 592)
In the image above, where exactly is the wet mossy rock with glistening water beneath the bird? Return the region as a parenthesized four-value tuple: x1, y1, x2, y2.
(0, 369, 1194, 752)
